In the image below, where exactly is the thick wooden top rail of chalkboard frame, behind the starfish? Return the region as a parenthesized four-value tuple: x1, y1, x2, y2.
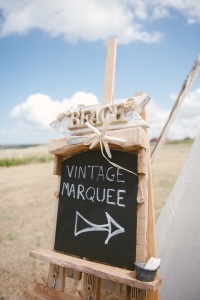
(49, 127, 148, 156)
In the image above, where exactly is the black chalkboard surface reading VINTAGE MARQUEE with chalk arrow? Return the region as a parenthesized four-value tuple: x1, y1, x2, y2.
(54, 150, 138, 270)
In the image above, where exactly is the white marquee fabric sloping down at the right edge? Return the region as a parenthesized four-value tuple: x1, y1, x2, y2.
(156, 132, 200, 300)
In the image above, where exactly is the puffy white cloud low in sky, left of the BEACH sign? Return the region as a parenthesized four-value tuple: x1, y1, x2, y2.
(10, 92, 98, 130)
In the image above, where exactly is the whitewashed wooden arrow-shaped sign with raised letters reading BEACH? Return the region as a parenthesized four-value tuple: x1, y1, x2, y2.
(50, 94, 150, 136)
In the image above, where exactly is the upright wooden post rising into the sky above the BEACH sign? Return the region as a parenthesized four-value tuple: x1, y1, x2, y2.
(103, 38, 117, 103)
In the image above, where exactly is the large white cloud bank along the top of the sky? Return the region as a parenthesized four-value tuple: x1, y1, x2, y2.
(0, 0, 200, 44)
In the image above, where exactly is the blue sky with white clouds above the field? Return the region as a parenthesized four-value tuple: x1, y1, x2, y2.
(0, 0, 200, 144)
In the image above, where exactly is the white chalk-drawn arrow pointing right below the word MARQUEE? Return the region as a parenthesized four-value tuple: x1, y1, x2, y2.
(74, 211, 125, 244)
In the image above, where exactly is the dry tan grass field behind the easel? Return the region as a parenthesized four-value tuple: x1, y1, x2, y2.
(0, 143, 192, 300)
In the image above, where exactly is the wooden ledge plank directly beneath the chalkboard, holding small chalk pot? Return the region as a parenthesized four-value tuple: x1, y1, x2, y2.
(30, 249, 161, 291)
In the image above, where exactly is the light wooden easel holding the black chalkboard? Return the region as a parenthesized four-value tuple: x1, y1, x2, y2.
(26, 38, 161, 300)
